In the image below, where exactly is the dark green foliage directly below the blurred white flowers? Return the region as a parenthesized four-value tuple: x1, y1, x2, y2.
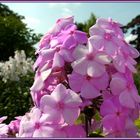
(0, 72, 34, 123)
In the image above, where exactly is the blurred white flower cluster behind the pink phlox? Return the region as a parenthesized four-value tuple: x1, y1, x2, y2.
(0, 50, 34, 82)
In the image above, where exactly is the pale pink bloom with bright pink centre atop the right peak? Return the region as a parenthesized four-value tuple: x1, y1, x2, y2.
(89, 25, 122, 57)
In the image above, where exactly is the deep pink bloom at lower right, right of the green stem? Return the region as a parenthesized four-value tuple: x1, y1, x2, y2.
(100, 96, 129, 132)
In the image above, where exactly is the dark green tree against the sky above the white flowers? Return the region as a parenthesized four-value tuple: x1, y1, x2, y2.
(0, 3, 40, 61)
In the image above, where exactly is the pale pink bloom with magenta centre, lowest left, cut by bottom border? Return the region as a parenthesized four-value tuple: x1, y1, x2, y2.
(18, 107, 63, 137)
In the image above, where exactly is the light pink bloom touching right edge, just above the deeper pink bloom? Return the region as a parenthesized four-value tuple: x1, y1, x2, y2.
(110, 72, 140, 109)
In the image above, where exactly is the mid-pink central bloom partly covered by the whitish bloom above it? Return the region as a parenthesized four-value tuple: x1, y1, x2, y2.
(69, 72, 109, 99)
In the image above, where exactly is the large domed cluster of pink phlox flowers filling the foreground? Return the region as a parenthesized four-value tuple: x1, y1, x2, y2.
(0, 17, 140, 137)
